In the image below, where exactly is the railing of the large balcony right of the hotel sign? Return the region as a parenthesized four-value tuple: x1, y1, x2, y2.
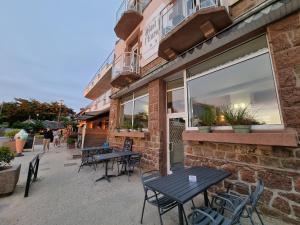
(160, 0, 219, 38)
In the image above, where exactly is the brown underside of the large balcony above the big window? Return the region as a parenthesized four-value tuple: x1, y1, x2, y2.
(158, 7, 232, 60)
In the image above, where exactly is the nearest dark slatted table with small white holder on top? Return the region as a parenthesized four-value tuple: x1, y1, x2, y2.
(145, 167, 231, 225)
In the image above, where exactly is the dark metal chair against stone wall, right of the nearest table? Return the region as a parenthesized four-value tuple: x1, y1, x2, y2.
(212, 179, 264, 225)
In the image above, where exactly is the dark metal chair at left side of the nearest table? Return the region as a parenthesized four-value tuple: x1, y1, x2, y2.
(141, 170, 178, 225)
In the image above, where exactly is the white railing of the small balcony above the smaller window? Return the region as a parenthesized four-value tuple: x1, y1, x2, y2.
(111, 52, 140, 80)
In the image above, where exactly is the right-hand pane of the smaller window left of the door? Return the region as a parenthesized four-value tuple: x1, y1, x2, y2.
(133, 95, 149, 128)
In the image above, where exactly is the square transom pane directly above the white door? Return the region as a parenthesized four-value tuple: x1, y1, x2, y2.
(167, 88, 184, 113)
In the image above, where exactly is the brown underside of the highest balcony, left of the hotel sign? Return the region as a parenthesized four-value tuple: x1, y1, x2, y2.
(114, 10, 143, 40)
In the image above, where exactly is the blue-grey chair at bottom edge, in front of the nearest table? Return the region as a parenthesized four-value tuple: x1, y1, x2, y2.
(188, 196, 249, 225)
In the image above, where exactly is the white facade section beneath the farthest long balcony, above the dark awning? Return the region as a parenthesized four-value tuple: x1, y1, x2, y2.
(85, 90, 111, 115)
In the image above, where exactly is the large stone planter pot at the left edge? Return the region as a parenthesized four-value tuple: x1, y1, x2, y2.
(0, 164, 21, 196)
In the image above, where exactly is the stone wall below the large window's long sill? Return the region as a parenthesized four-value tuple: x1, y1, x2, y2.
(185, 142, 300, 224)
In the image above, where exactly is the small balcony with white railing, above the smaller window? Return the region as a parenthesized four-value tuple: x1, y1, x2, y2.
(111, 52, 140, 88)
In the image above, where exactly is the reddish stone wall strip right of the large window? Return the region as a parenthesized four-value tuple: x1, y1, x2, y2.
(267, 12, 300, 134)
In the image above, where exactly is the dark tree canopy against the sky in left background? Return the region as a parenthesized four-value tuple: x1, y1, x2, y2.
(0, 98, 75, 126)
